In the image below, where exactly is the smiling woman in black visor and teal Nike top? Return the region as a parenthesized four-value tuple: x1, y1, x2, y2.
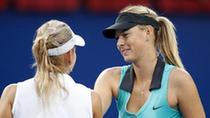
(94, 6, 205, 118)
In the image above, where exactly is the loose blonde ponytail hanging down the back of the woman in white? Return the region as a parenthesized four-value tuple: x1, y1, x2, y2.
(32, 36, 63, 105)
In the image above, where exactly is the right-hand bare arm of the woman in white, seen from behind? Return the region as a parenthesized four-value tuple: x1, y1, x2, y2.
(91, 92, 102, 118)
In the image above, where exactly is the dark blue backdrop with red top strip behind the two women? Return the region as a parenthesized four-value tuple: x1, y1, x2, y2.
(0, 0, 210, 118)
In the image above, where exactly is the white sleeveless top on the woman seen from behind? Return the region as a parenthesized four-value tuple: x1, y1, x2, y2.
(12, 74, 93, 118)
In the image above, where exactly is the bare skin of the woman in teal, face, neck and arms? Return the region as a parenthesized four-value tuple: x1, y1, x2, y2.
(94, 26, 205, 118)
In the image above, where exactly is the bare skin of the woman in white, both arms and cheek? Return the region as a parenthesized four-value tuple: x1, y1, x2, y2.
(0, 48, 102, 118)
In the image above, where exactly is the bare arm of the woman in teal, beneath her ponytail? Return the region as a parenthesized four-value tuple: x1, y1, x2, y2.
(173, 70, 205, 118)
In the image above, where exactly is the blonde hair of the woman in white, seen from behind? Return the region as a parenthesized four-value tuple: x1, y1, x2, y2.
(32, 20, 72, 104)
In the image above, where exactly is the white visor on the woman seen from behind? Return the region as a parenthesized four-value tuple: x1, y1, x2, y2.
(48, 31, 85, 56)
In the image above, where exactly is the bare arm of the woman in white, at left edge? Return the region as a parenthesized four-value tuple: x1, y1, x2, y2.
(0, 84, 16, 118)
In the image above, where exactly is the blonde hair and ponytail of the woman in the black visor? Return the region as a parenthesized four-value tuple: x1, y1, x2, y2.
(120, 5, 184, 68)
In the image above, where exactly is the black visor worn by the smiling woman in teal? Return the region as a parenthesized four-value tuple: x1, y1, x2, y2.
(103, 12, 159, 38)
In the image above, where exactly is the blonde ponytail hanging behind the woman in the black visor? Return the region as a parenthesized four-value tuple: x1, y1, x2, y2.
(155, 16, 184, 68)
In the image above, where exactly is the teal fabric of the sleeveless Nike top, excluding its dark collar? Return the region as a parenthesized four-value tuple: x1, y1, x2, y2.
(116, 64, 182, 118)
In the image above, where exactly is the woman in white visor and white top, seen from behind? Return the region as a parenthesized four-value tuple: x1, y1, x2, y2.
(0, 20, 102, 118)
